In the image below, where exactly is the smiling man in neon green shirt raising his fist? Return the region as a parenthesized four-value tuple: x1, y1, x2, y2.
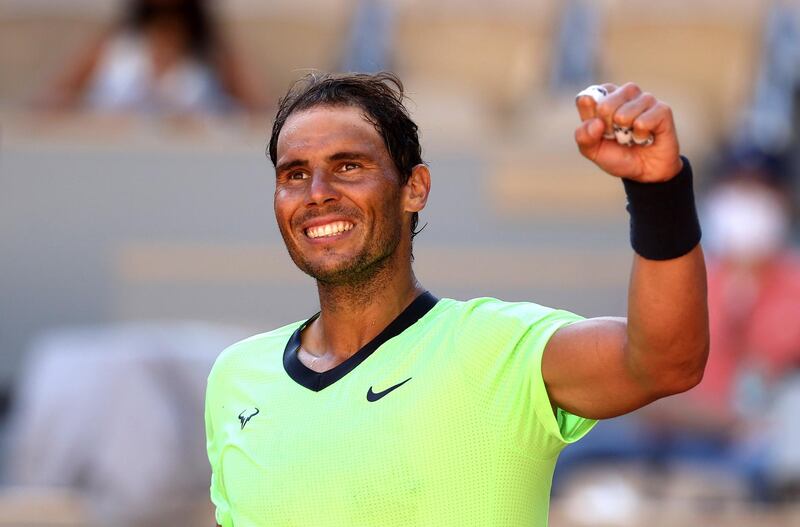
(206, 74, 708, 527)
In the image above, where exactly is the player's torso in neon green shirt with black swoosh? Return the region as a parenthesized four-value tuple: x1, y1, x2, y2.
(207, 299, 591, 527)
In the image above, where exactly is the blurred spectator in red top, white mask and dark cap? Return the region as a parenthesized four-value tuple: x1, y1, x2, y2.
(556, 145, 800, 501)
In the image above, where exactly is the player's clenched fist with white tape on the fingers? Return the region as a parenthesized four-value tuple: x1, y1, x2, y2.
(575, 82, 683, 183)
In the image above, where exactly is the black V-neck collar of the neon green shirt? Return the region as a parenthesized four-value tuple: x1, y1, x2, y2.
(283, 291, 439, 392)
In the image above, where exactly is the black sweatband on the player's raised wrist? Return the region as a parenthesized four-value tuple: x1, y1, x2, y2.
(622, 156, 701, 260)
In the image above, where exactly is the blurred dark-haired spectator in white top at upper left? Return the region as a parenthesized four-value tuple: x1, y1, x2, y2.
(40, 0, 264, 114)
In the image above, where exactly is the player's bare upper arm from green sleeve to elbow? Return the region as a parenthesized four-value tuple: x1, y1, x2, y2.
(542, 317, 660, 419)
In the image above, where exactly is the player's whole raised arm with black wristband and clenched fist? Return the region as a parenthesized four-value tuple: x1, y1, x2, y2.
(542, 84, 708, 419)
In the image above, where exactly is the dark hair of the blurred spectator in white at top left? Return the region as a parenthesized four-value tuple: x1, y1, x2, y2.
(122, 0, 217, 61)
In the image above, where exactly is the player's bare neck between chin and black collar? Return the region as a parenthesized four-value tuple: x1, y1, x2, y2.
(303, 250, 424, 366)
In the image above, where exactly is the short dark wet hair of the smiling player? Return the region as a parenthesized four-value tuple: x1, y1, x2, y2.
(268, 72, 423, 239)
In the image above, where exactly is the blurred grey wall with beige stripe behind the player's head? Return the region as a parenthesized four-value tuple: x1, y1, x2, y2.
(0, 143, 630, 383)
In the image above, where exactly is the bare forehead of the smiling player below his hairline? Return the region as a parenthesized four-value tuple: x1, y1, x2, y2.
(277, 106, 388, 162)
